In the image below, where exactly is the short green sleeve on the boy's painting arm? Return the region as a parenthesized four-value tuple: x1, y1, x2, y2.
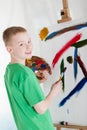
(21, 71, 45, 106)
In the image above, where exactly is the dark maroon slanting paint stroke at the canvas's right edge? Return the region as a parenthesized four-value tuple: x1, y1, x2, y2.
(76, 55, 87, 78)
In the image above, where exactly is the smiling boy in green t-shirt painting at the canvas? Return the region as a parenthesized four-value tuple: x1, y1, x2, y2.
(3, 26, 62, 130)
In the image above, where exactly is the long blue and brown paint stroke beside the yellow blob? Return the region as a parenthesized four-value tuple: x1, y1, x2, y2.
(45, 22, 87, 41)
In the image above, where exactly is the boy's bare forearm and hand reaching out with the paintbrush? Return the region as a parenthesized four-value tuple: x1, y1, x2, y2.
(34, 81, 62, 114)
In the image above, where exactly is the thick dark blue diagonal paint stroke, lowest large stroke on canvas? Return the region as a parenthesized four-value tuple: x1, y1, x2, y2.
(59, 78, 87, 107)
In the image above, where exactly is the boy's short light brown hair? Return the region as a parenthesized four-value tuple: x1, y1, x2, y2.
(3, 26, 27, 46)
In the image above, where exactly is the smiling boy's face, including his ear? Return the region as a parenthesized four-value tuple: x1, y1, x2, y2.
(7, 32, 32, 60)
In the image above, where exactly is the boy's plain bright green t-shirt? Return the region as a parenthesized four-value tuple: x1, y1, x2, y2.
(4, 63, 54, 130)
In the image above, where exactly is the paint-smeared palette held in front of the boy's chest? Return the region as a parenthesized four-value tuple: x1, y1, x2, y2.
(26, 56, 52, 80)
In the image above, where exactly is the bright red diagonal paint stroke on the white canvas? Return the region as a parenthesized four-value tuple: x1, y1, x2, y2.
(52, 33, 82, 68)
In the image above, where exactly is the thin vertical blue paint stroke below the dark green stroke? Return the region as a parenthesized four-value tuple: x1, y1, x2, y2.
(73, 48, 78, 79)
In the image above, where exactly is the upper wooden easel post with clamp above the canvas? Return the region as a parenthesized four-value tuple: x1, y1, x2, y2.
(57, 0, 72, 23)
